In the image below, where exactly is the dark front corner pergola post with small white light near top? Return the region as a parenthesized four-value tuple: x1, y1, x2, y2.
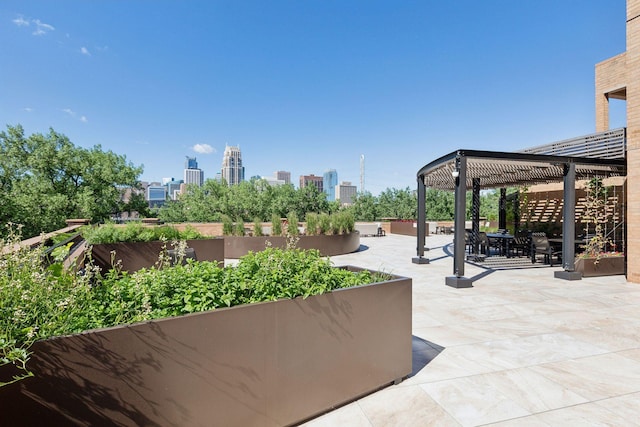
(445, 154, 472, 288)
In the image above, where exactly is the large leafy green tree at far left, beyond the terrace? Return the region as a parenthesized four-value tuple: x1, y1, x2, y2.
(0, 125, 142, 237)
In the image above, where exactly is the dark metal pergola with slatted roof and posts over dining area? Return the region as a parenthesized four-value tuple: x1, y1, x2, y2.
(413, 149, 626, 288)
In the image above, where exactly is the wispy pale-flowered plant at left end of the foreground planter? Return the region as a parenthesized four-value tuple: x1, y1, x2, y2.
(0, 223, 93, 386)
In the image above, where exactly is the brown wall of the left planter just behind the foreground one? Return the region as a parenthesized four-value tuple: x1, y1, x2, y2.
(91, 238, 224, 272)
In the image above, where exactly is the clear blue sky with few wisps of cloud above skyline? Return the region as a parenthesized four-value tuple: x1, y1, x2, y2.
(0, 0, 626, 195)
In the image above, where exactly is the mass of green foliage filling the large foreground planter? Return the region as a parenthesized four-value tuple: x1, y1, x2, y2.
(0, 229, 387, 386)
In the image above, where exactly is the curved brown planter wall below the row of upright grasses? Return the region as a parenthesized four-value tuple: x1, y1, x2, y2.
(224, 232, 360, 258)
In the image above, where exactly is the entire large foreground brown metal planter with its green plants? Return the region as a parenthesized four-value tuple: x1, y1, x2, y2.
(0, 229, 411, 425)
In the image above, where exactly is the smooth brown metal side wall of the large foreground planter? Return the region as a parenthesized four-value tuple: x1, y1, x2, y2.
(0, 268, 412, 427)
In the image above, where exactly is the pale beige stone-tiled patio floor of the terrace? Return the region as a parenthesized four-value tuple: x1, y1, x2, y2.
(305, 235, 640, 427)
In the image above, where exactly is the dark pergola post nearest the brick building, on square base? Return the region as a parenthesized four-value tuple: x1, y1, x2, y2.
(553, 163, 582, 280)
